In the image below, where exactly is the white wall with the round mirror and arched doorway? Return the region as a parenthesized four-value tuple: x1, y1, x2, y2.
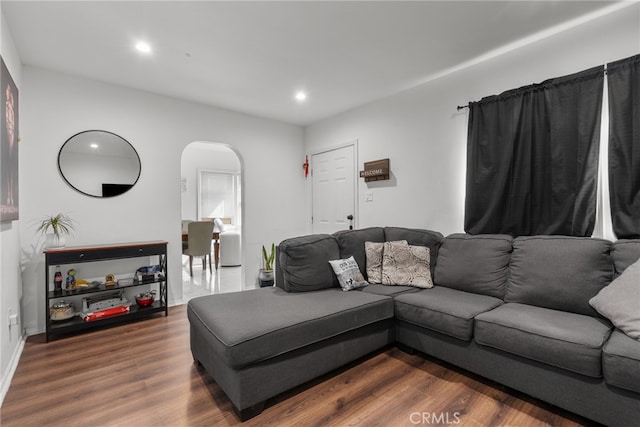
(20, 66, 306, 332)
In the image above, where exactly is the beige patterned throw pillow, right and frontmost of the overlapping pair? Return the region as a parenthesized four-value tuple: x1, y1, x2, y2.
(382, 241, 433, 288)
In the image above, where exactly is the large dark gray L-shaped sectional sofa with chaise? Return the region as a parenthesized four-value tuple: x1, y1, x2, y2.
(187, 227, 640, 426)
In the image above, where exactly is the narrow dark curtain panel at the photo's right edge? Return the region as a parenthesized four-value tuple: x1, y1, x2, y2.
(607, 55, 640, 239)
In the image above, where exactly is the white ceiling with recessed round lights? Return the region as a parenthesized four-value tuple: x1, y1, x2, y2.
(1, 0, 616, 126)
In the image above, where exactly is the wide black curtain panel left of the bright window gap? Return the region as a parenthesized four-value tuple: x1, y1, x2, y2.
(465, 66, 604, 236)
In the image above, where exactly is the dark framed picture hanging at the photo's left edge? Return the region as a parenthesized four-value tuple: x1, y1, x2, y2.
(0, 56, 20, 222)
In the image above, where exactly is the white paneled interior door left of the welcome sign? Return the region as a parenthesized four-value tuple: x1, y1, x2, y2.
(311, 145, 356, 234)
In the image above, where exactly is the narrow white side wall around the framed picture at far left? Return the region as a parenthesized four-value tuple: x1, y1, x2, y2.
(0, 7, 24, 404)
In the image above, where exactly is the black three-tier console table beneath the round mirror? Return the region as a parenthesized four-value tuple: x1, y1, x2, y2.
(44, 240, 169, 341)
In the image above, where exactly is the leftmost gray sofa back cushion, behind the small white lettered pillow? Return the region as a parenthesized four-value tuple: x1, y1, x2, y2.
(279, 234, 340, 292)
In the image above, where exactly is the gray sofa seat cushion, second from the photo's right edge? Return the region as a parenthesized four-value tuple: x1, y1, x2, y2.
(474, 303, 611, 378)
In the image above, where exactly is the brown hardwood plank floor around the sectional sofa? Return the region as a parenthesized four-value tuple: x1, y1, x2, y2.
(0, 306, 584, 427)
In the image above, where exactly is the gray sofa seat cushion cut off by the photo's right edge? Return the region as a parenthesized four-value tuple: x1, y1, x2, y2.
(602, 329, 640, 393)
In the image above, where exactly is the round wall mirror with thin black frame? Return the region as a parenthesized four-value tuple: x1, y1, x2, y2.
(58, 130, 141, 197)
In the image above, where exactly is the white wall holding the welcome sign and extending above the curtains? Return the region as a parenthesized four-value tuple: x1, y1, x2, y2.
(305, 4, 640, 235)
